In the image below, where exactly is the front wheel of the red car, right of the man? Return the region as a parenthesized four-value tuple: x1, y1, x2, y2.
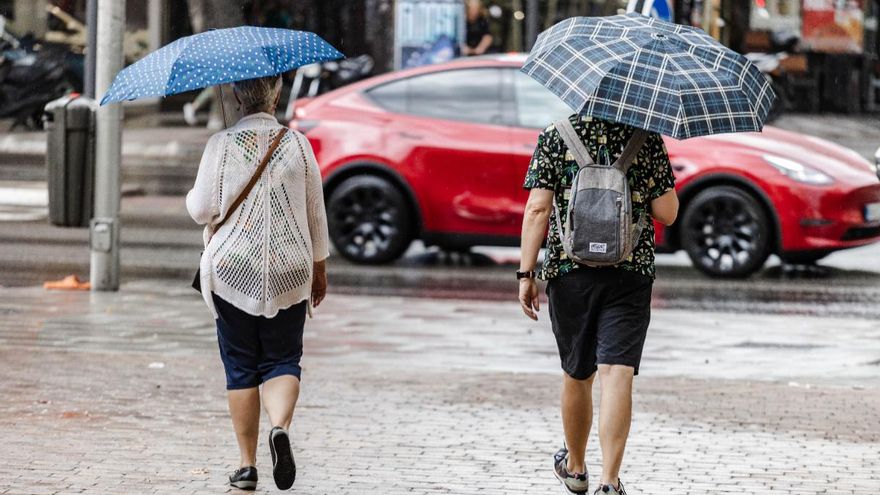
(681, 186, 771, 278)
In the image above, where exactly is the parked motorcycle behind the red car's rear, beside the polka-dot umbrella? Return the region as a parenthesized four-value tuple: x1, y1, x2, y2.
(284, 55, 376, 121)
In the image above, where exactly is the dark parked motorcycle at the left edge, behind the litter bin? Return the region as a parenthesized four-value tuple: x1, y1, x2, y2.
(0, 18, 76, 130)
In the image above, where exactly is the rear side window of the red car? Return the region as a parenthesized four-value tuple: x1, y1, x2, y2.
(368, 68, 504, 125)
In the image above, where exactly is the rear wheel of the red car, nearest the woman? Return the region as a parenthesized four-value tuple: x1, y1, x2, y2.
(327, 175, 413, 263)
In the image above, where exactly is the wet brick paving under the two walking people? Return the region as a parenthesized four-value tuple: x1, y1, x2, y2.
(0, 282, 880, 495)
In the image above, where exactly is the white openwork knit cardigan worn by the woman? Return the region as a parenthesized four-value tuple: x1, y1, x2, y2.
(186, 113, 329, 318)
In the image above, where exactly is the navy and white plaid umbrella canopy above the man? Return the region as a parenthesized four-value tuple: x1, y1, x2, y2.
(522, 14, 776, 139)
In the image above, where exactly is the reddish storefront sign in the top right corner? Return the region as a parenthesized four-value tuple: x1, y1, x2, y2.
(803, 0, 864, 54)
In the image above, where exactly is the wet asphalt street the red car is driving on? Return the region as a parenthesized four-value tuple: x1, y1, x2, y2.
(0, 187, 880, 319)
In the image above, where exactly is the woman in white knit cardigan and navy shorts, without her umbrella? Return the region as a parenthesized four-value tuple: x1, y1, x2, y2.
(186, 76, 330, 490)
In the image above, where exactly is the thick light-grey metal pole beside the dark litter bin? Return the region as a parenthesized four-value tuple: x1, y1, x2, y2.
(90, 0, 125, 291)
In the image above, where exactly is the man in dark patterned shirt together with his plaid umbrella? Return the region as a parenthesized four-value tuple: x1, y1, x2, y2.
(517, 11, 775, 495)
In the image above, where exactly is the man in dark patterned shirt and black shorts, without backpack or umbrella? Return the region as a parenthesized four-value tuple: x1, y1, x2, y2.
(519, 114, 678, 494)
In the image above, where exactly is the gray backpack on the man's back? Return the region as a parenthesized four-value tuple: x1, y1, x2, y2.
(554, 118, 648, 266)
